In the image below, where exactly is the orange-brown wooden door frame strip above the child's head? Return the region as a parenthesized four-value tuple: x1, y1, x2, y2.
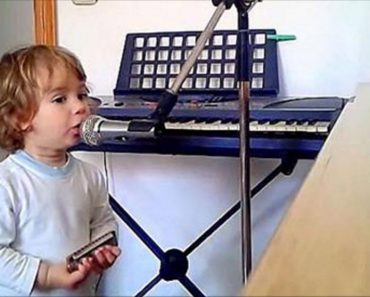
(33, 0, 57, 45)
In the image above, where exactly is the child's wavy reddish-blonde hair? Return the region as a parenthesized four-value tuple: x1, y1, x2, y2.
(0, 45, 86, 152)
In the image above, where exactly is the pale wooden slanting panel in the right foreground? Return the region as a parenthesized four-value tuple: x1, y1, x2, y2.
(242, 84, 370, 296)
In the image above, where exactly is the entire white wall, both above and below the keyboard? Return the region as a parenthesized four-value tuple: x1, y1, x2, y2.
(58, 0, 370, 296)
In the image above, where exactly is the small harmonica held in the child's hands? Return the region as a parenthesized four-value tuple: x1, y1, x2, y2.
(66, 231, 117, 272)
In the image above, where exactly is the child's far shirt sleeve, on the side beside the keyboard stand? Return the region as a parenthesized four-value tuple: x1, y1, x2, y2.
(90, 171, 118, 240)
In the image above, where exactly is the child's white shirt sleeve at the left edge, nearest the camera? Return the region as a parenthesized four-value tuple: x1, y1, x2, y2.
(0, 185, 40, 295)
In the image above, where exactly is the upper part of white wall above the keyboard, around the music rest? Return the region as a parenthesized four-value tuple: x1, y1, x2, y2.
(58, 0, 370, 96)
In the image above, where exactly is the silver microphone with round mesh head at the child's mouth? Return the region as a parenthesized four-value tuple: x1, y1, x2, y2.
(80, 115, 155, 145)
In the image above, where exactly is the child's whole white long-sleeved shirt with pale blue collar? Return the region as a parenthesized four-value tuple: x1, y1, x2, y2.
(0, 151, 117, 296)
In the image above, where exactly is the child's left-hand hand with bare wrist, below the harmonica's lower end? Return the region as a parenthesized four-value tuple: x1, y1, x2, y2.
(36, 258, 93, 290)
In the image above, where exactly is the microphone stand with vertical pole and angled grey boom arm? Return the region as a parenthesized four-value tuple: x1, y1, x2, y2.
(149, 0, 261, 283)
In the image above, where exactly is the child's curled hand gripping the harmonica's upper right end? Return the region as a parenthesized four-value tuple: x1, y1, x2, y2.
(88, 245, 121, 274)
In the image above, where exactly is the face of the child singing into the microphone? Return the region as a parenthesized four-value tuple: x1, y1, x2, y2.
(25, 64, 90, 153)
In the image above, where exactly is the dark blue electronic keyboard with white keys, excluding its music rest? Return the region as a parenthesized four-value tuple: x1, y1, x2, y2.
(74, 96, 347, 159)
